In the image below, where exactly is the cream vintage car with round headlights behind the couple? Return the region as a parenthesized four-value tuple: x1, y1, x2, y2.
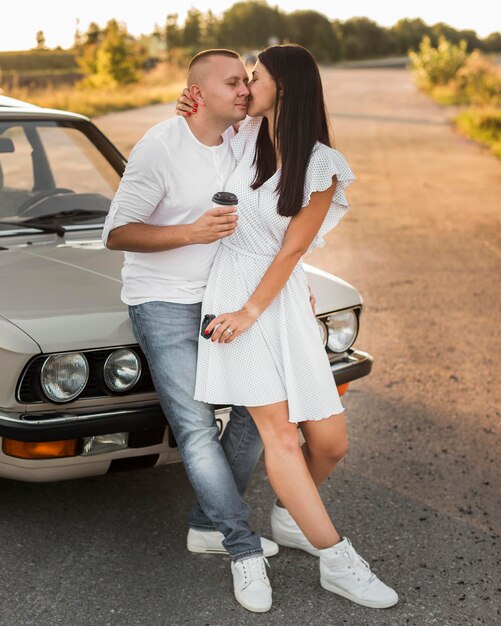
(0, 96, 372, 482)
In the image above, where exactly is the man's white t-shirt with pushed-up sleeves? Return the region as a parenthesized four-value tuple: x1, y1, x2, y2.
(102, 116, 236, 305)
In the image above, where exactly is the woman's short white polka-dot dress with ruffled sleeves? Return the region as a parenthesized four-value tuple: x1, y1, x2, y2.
(195, 118, 355, 422)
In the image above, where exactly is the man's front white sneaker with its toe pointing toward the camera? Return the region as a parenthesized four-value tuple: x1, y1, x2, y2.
(231, 556, 272, 613)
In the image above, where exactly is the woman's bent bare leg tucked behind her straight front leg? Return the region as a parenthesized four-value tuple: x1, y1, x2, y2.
(277, 412, 348, 506)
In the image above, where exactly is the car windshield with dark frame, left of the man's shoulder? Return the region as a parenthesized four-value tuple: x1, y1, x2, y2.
(0, 120, 120, 234)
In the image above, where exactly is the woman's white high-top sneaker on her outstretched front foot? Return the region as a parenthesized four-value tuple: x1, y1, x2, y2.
(320, 537, 398, 609)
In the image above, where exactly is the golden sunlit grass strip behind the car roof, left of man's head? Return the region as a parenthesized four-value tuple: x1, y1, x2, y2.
(5, 63, 185, 117)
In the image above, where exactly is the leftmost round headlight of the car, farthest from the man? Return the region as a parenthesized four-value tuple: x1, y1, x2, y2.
(40, 352, 89, 402)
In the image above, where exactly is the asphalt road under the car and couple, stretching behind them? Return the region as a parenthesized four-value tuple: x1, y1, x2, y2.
(0, 69, 501, 626)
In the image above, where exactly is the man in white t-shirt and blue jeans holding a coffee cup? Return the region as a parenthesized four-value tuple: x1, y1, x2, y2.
(103, 50, 278, 612)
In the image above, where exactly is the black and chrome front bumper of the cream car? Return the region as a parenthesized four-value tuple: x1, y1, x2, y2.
(0, 350, 373, 482)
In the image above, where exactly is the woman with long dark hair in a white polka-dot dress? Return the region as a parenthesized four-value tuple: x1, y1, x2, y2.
(181, 45, 398, 608)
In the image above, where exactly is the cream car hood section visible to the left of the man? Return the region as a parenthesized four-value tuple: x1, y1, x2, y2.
(0, 240, 136, 352)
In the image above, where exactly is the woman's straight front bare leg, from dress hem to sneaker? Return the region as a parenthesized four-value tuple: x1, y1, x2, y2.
(247, 402, 340, 549)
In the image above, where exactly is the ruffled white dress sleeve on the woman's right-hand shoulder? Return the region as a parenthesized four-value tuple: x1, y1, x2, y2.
(303, 143, 356, 252)
